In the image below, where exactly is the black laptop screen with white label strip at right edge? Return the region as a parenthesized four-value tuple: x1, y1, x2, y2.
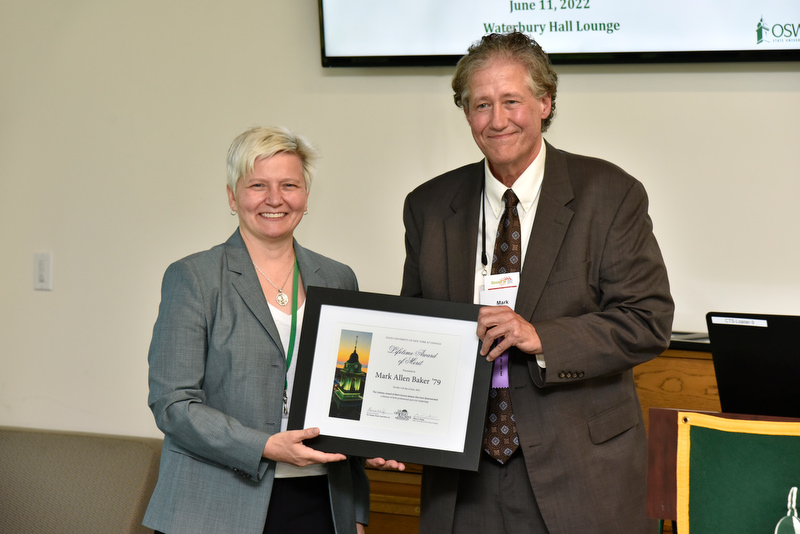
(706, 312, 800, 418)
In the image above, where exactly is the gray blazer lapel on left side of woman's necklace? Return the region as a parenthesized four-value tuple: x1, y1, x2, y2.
(225, 230, 286, 356)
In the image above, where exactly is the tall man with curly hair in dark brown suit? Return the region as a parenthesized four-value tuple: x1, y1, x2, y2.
(402, 33, 674, 534)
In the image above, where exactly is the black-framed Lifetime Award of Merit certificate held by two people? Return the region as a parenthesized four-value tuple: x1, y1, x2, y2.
(289, 287, 492, 471)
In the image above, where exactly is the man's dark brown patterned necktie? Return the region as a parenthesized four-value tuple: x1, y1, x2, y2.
(483, 189, 522, 464)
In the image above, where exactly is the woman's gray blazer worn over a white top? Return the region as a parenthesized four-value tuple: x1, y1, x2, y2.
(144, 230, 369, 534)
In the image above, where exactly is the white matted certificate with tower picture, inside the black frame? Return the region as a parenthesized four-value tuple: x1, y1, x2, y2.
(305, 306, 477, 451)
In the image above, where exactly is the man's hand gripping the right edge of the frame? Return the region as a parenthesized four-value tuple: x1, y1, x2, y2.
(477, 306, 542, 362)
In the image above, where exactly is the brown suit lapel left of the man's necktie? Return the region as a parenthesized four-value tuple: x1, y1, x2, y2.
(444, 161, 484, 302)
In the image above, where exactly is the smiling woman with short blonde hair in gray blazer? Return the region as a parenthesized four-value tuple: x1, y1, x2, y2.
(144, 128, 372, 534)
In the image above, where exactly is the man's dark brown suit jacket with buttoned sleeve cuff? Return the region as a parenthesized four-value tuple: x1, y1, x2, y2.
(402, 144, 674, 534)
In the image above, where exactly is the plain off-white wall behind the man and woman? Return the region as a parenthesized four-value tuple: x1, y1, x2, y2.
(0, 0, 800, 436)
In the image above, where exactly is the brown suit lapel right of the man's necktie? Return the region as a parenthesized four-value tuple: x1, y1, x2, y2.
(516, 143, 574, 320)
